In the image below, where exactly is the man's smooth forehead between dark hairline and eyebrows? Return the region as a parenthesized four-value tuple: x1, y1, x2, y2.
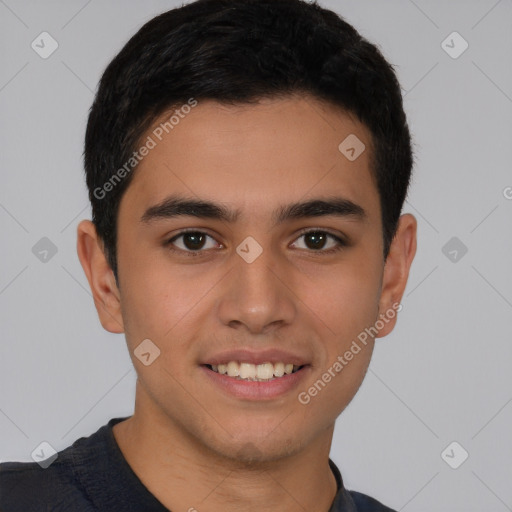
(122, 97, 378, 221)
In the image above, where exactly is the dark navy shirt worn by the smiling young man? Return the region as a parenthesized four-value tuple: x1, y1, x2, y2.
(0, 418, 394, 512)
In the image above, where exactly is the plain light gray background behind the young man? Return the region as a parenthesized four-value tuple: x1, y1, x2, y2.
(0, 0, 512, 512)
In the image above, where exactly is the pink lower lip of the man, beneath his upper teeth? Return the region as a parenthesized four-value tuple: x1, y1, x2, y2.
(201, 365, 309, 400)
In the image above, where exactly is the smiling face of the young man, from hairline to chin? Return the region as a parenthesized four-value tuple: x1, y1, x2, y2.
(79, 97, 414, 460)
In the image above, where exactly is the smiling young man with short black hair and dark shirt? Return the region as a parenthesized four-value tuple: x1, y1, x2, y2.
(0, 0, 416, 512)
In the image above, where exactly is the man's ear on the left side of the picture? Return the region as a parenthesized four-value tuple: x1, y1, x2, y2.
(76, 220, 124, 334)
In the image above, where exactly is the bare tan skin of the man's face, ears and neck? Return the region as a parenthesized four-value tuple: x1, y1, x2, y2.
(77, 96, 416, 512)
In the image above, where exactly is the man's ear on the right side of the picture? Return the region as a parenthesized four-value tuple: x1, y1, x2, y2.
(376, 213, 417, 338)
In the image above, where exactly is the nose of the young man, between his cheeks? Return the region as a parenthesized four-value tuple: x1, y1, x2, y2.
(217, 244, 297, 334)
